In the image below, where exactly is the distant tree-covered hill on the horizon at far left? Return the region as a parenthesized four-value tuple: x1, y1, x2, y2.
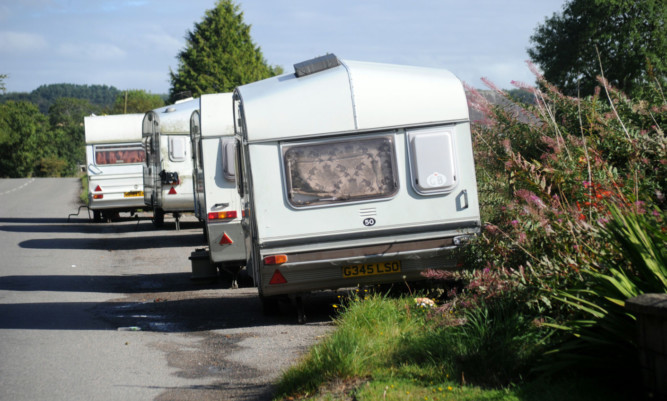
(0, 84, 121, 114)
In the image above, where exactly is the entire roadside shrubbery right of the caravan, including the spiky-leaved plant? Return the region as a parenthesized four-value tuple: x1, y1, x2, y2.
(425, 62, 667, 383)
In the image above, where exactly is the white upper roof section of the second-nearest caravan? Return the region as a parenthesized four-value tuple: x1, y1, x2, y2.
(200, 93, 234, 137)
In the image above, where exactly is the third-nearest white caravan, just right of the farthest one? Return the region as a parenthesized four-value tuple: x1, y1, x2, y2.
(142, 98, 199, 229)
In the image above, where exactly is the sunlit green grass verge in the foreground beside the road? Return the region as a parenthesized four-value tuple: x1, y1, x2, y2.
(276, 295, 623, 401)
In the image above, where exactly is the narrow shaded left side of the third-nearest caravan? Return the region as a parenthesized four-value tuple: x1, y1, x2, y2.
(141, 111, 161, 208)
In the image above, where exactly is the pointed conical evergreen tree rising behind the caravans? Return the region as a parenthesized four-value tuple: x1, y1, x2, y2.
(169, 0, 282, 102)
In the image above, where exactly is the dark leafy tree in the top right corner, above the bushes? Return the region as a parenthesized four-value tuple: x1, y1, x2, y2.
(528, 0, 667, 95)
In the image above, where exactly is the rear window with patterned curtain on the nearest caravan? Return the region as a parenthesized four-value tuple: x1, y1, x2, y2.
(282, 135, 398, 207)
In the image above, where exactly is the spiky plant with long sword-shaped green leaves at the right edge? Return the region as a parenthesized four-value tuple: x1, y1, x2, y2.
(541, 206, 667, 376)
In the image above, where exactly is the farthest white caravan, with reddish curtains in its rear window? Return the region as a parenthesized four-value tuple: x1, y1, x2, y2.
(83, 114, 145, 222)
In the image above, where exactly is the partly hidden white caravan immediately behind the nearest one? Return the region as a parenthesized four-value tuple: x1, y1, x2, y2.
(190, 93, 246, 282)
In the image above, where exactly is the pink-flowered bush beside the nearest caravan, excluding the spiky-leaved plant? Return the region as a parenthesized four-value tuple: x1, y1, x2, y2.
(456, 63, 667, 317)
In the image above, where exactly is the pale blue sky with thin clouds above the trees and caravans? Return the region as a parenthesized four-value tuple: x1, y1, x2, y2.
(0, 0, 565, 94)
